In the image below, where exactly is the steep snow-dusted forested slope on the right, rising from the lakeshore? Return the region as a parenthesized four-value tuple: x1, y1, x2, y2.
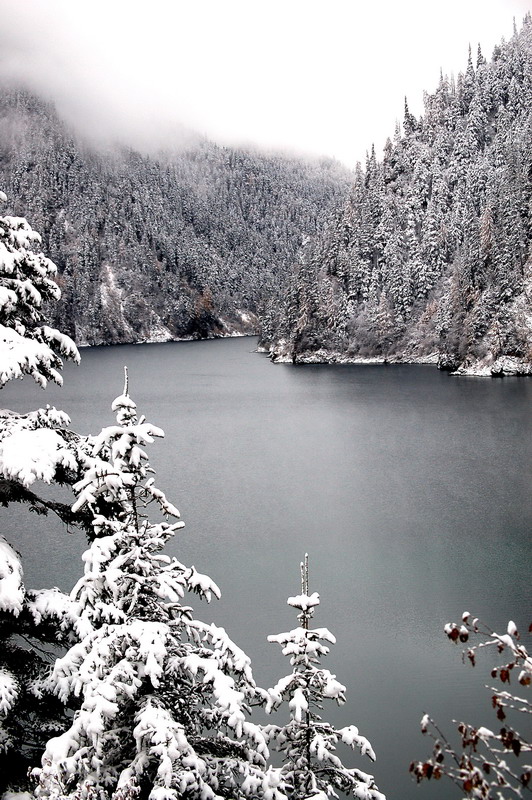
(263, 15, 532, 374)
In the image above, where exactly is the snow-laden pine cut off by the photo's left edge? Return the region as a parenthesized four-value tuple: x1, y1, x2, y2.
(0, 193, 79, 793)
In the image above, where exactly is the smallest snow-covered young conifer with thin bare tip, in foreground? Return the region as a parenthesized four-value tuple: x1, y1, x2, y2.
(265, 555, 385, 800)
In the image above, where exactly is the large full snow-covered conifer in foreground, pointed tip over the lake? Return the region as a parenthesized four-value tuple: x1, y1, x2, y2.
(35, 376, 278, 800)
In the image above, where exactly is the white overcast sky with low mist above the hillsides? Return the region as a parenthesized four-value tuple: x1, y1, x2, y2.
(0, 0, 532, 166)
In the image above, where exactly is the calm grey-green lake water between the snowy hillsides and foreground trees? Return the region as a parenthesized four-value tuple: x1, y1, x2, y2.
(2, 339, 532, 800)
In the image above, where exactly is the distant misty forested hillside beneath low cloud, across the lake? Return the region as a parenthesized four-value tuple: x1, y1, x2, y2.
(0, 90, 351, 344)
